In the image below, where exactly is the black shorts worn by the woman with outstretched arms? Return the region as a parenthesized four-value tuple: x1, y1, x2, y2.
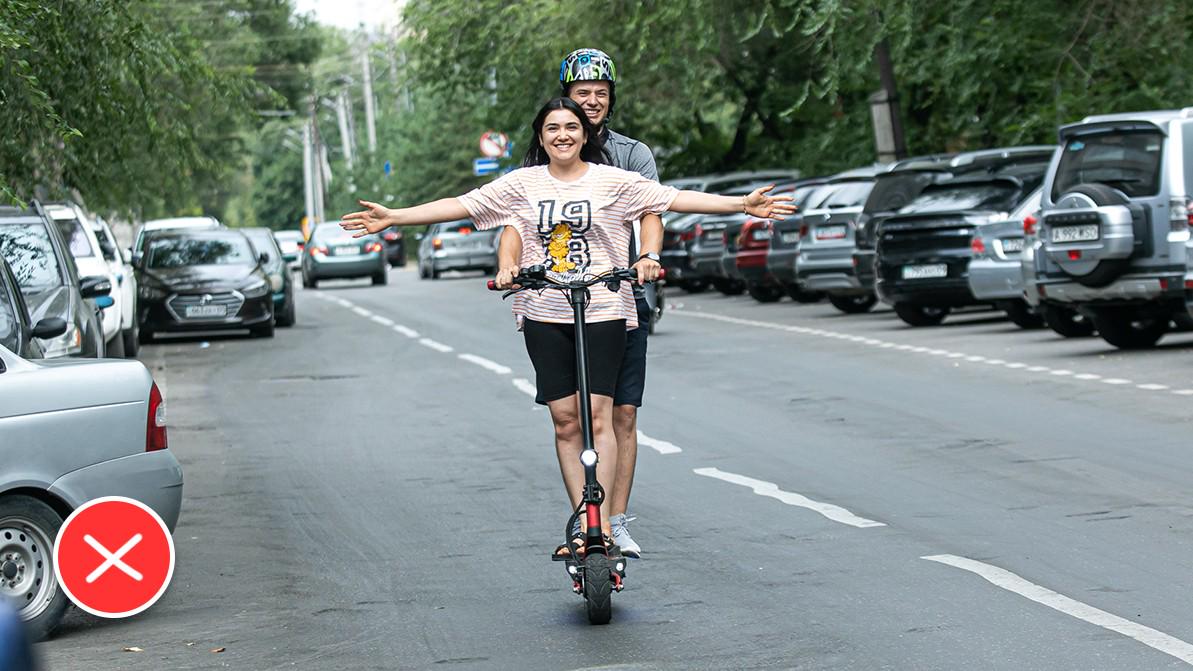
(523, 319, 625, 405)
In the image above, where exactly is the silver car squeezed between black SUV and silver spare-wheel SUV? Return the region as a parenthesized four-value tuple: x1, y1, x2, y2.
(969, 189, 1044, 328)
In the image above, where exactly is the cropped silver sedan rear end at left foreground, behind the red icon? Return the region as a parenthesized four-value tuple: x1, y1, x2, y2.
(0, 346, 183, 640)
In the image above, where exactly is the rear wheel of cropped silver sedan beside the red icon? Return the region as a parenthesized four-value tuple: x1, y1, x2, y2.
(0, 494, 67, 641)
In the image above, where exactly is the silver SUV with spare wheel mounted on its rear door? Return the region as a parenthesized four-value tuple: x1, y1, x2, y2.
(1027, 107, 1193, 349)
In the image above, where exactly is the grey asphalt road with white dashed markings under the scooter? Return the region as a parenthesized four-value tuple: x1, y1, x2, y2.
(38, 267, 1193, 671)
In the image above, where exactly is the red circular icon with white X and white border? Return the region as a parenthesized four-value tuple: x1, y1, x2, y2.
(54, 497, 174, 618)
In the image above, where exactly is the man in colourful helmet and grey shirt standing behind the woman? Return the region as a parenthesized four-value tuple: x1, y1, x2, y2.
(497, 49, 663, 558)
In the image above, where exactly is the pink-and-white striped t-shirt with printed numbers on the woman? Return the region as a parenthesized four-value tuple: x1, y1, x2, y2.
(459, 164, 678, 328)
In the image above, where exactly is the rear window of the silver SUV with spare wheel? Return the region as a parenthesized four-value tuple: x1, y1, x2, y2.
(1052, 133, 1164, 197)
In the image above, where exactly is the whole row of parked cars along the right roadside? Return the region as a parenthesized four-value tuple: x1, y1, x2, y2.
(662, 107, 1193, 347)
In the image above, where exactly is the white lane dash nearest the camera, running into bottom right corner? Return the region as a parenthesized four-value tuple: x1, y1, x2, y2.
(920, 554, 1193, 664)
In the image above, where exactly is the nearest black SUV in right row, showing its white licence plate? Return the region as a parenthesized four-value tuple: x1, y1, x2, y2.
(876, 156, 1047, 326)
